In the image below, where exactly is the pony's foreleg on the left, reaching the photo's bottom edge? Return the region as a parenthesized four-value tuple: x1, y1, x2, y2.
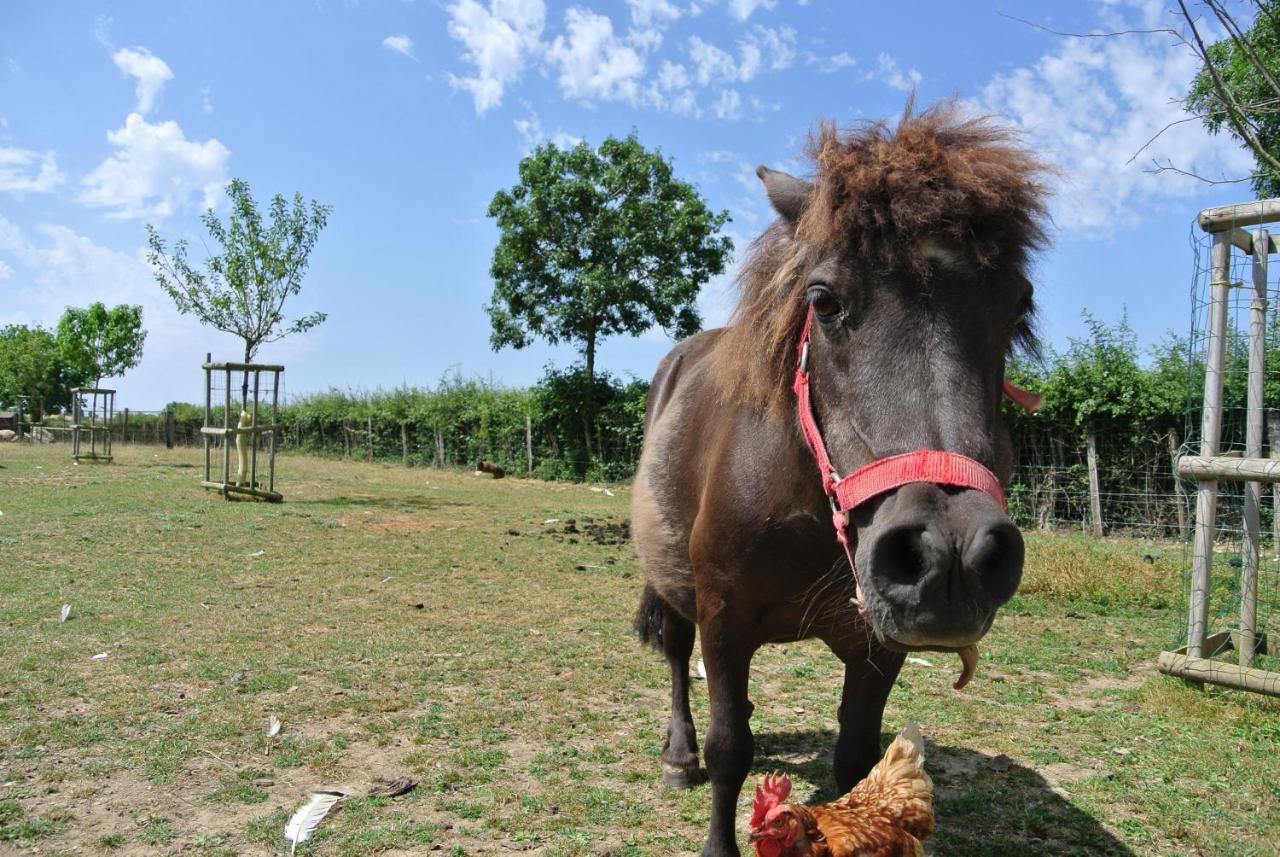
(698, 602, 755, 857)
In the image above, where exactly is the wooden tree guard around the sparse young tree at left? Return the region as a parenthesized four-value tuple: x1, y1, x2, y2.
(200, 354, 284, 503)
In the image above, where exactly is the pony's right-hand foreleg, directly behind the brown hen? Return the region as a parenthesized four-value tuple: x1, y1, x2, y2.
(833, 643, 905, 793)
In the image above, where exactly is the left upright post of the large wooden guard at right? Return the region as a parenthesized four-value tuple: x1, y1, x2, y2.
(1187, 234, 1231, 657)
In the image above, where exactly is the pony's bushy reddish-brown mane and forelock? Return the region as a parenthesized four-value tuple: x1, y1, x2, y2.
(716, 101, 1048, 408)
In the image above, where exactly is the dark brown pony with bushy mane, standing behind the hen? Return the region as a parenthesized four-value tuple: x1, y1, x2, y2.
(632, 102, 1044, 856)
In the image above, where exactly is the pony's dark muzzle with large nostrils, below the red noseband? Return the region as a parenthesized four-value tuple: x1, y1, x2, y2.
(858, 484, 1025, 649)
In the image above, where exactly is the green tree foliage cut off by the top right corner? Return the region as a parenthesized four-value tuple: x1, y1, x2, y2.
(1178, 0, 1280, 197)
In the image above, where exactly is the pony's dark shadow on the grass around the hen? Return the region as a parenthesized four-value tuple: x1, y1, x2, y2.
(749, 729, 1134, 857)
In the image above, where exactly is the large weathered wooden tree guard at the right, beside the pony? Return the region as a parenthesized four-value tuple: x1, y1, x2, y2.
(1157, 200, 1280, 696)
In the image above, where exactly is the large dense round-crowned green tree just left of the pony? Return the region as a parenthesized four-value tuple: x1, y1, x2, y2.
(485, 134, 733, 454)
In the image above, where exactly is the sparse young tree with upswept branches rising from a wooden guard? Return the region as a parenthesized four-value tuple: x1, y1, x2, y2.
(147, 179, 333, 398)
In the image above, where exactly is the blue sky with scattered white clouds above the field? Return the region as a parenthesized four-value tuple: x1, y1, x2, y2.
(0, 0, 1251, 409)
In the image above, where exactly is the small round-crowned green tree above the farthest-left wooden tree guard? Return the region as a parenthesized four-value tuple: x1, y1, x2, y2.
(58, 302, 147, 386)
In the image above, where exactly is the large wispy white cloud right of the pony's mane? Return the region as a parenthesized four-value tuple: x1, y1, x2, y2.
(972, 4, 1252, 233)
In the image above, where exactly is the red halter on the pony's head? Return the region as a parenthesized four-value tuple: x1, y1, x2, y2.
(791, 307, 1041, 603)
